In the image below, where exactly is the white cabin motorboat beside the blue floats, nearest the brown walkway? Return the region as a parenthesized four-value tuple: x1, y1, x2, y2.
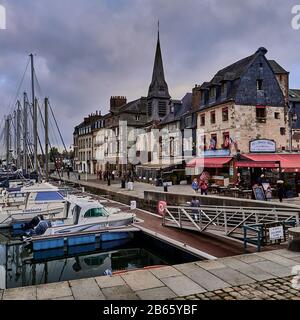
(43, 196, 136, 236)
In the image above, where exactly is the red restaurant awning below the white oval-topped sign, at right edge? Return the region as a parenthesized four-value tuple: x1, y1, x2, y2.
(235, 153, 300, 172)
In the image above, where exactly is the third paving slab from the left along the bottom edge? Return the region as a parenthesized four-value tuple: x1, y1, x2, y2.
(69, 278, 105, 300)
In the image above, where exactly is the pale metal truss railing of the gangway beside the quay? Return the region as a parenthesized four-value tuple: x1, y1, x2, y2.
(162, 206, 300, 237)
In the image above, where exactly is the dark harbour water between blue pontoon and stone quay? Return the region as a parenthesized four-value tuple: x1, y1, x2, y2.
(0, 231, 200, 289)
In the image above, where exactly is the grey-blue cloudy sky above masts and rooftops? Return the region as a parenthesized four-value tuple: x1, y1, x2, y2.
(0, 0, 300, 146)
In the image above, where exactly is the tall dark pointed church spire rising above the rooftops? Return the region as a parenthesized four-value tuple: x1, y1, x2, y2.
(148, 20, 170, 99)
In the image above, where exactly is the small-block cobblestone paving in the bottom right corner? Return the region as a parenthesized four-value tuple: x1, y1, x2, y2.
(175, 276, 300, 300)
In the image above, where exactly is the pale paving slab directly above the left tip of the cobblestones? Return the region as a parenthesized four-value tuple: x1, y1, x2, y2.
(161, 276, 206, 296)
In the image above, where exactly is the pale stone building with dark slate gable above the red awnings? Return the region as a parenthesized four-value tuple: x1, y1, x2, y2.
(192, 48, 289, 155)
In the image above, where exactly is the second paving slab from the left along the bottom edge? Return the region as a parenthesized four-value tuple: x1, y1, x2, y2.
(36, 281, 72, 300)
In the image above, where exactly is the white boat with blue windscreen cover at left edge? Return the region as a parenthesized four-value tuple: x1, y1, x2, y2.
(0, 183, 65, 228)
